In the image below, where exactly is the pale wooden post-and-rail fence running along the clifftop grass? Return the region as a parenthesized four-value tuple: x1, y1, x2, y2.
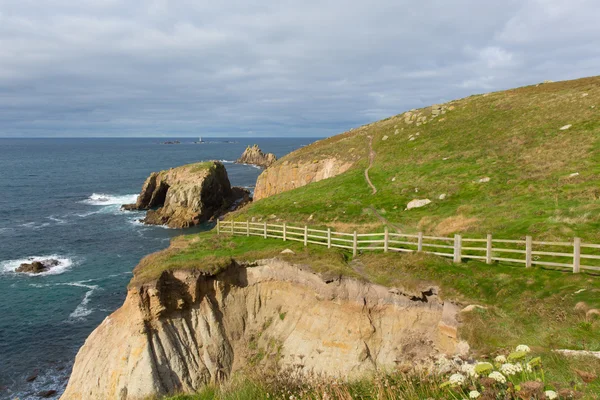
(217, 221, 600, 273)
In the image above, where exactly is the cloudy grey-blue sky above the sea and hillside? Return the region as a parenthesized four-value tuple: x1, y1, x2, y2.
(0, 0, 600, 137)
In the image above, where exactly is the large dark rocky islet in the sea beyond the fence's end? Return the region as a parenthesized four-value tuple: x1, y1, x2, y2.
(123, 161, 250, 228)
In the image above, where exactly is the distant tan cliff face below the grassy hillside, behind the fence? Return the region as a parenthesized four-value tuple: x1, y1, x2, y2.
(254, 157, 353, 200)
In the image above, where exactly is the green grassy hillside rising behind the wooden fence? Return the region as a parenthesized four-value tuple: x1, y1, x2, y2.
(234, 77, 600, 243)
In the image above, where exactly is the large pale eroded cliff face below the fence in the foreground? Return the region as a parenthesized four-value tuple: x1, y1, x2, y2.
(61, 259, 461, 400)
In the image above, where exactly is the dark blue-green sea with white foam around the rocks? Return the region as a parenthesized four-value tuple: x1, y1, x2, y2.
(0, 138, 314, 399)
